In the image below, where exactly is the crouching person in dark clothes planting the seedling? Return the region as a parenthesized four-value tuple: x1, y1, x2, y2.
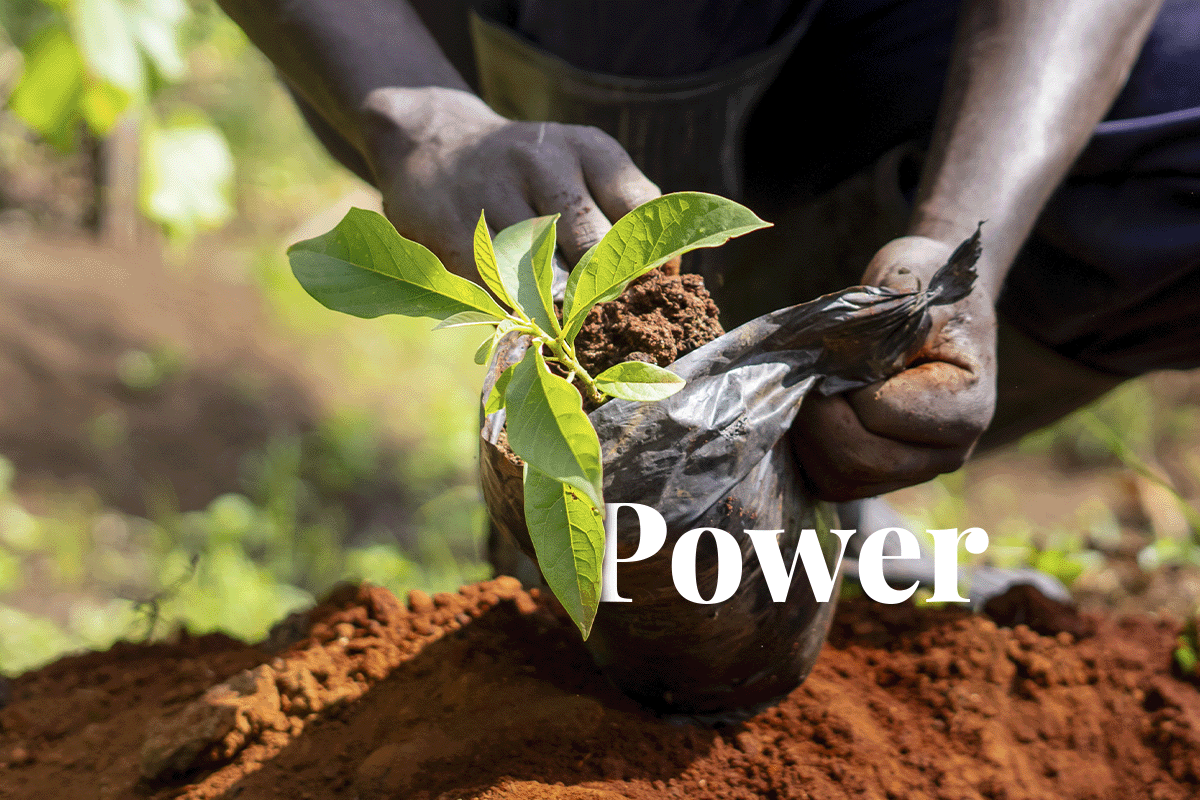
(218, 0, 1200, 513)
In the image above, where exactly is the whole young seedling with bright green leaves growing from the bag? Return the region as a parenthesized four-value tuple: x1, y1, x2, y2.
(288, 192, 768, 638)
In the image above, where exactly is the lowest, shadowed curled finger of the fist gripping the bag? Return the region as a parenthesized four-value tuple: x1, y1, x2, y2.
(792, 395, 971, 501)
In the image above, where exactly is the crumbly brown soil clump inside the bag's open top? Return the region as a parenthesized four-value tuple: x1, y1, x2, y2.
(575, 271, 725, 375)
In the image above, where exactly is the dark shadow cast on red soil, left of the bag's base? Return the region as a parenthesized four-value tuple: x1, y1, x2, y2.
(175, 603, 715, 800)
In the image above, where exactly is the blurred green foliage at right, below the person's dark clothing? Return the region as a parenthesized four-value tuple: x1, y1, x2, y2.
(900, 373, 1200, 604)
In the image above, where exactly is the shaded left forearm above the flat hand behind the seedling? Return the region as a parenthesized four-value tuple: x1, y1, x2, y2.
(217, 0, 468, 161)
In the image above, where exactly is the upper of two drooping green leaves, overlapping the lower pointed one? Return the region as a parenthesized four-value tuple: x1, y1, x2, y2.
(504, 347, 604, 509)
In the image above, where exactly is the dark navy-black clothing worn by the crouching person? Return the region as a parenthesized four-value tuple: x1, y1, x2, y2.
(499, 0, 1200, 375)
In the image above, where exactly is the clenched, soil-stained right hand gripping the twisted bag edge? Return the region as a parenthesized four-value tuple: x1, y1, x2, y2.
(792, 236, 996, 500)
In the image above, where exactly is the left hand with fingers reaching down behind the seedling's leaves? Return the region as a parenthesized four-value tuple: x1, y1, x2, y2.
(365, 88, 660, 281)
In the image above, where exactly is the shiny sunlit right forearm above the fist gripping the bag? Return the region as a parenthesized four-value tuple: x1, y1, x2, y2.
(910, 0, 1162, 297)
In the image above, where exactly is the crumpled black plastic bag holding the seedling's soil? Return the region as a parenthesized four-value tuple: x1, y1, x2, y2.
(480, 231, 980, 718)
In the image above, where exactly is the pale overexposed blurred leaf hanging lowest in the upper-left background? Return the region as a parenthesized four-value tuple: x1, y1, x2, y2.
(142, 116, 233, 234)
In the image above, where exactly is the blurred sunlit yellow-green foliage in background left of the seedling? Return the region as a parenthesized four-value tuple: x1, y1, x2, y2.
(0, 0, 490, 674)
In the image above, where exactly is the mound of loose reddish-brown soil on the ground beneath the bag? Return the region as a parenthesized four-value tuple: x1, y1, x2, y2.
(0, 578, 1200, 800)
